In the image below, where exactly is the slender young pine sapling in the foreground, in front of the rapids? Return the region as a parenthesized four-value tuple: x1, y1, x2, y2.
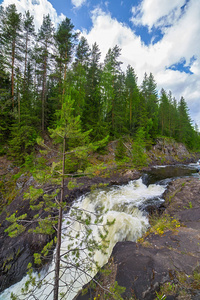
(6, 96, 111, 300)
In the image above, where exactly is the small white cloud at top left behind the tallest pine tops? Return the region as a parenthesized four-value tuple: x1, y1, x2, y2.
(2, 0, 65, 30)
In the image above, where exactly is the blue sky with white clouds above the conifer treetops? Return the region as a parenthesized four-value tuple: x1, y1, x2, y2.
(0, 0, 200, 129)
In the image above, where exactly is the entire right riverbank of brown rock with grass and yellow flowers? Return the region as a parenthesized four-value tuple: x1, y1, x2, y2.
(77, 177, 200, 300)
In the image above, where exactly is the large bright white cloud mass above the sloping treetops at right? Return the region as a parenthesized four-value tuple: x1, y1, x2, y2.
(84, 0, 200, 128)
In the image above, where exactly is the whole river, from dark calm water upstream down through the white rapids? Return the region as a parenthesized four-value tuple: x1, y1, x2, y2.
(0, 164, 199, 300)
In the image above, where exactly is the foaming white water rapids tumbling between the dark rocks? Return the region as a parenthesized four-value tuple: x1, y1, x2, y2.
(0, 179, 165, 300)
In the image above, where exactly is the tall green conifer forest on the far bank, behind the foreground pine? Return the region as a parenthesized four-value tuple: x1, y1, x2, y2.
(0, 4, 200, 162)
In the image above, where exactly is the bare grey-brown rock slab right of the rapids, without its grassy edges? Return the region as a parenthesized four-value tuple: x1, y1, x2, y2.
(112, 177, 200, 300)
